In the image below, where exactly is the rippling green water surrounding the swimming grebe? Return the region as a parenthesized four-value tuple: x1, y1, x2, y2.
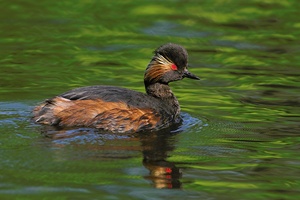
(0, 0, 300, 199)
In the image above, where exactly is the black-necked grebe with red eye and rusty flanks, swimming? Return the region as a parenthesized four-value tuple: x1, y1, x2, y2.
(33, 43, 199, 133)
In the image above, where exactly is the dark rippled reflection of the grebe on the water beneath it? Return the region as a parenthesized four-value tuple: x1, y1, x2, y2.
(36, 113, 202, 189)
